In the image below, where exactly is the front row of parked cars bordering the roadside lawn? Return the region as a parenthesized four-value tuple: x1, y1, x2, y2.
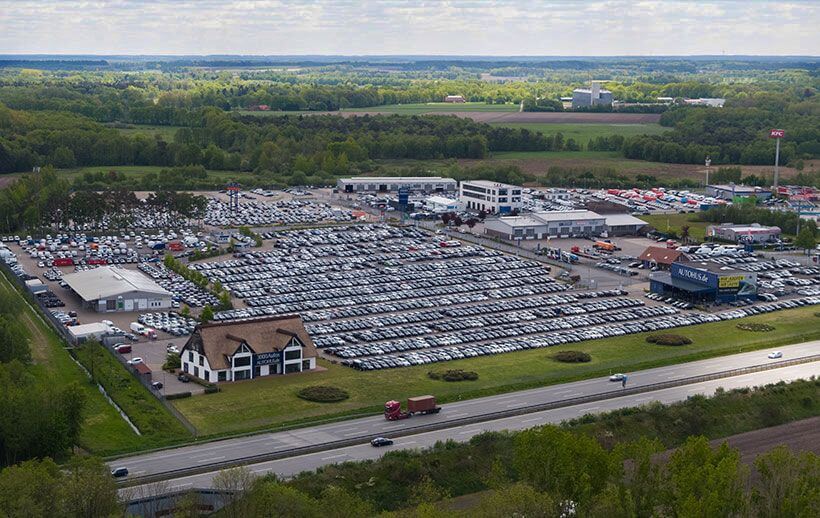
(341, 297, 820, 371)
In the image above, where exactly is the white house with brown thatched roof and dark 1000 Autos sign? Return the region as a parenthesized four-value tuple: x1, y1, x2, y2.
(180, 315, 316, 383)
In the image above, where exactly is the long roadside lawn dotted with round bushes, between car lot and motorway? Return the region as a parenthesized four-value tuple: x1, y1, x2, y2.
(174, 307, 820, 435)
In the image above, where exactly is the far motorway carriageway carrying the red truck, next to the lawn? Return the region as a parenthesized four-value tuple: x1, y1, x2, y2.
(109, 340, 820, 484)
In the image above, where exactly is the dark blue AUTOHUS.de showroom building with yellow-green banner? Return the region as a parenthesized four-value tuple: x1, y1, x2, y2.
(649, 262, 757, 303)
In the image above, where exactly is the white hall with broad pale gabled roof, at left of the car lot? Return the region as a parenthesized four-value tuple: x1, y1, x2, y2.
(63, 266, 171, 312)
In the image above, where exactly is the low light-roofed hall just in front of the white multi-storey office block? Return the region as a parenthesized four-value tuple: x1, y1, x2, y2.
(484, 210, 606, 240)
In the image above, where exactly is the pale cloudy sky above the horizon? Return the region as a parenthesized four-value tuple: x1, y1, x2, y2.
(0, 0, 820, 56)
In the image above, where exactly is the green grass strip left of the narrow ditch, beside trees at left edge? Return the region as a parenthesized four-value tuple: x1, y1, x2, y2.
(0, 273, 152, 456)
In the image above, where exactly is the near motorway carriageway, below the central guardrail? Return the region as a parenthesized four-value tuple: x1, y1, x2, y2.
(120, 358, 820, 498)
